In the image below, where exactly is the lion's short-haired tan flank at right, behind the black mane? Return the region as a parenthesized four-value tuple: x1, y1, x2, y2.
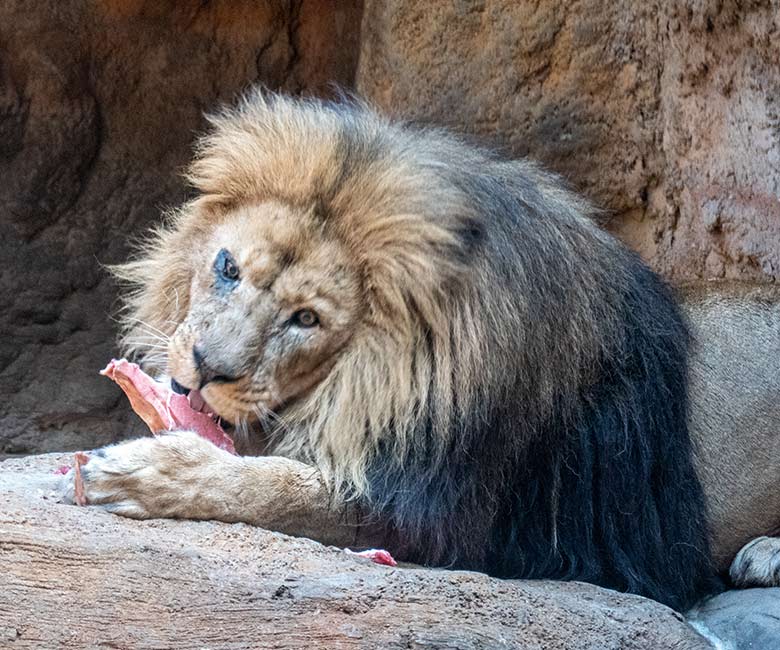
(682, 282, 780, 568)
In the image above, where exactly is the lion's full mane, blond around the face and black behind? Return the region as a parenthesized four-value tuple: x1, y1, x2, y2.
(114, 92, 710, 609)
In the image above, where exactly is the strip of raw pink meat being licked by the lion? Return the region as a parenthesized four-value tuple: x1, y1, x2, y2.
(100, 359, 236, 454)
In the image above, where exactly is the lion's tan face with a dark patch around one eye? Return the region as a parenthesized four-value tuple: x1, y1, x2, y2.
(168, 202, 365, 422)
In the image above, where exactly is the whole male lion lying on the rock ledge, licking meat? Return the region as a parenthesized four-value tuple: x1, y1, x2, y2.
(62, 90, 780, 610)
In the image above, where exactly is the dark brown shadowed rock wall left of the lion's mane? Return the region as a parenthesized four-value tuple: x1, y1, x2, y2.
(0, 0, 360, 453)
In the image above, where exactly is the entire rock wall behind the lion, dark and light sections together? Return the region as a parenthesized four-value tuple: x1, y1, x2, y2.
(0, 0, 780, 454)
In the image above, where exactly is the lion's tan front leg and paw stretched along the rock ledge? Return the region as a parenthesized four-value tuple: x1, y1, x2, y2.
(63, 432, 372, 546)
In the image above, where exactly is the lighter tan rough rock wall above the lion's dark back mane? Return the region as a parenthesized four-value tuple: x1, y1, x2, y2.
(357, 0, 780, 281)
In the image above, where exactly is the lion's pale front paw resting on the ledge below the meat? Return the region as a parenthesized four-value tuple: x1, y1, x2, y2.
(62, 431, 238, 519)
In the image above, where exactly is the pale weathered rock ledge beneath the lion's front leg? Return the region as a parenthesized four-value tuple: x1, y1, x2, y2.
(0, 455, 709, 650)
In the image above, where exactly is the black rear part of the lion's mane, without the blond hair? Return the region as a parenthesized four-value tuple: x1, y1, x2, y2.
(368, 146, 714, 610)
